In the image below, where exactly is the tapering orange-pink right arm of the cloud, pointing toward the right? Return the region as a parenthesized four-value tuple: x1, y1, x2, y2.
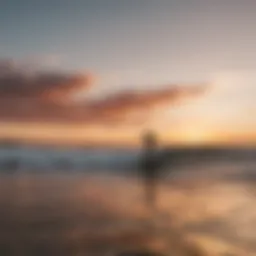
(87, 85, 204, 125)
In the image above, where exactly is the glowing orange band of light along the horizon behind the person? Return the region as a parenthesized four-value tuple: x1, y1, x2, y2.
(0, 123, 256, 146)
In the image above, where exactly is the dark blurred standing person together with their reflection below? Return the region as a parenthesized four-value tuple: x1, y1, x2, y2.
(140, 131, 161, 213)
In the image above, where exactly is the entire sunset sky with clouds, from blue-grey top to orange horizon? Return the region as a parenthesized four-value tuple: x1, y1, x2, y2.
(0, 0, 256, 144)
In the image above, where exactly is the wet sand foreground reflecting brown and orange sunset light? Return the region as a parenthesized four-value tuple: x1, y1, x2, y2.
(0, 162, 256, 256)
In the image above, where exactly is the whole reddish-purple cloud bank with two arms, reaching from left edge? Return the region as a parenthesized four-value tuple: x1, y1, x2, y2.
(0, 60, 205, 125)
